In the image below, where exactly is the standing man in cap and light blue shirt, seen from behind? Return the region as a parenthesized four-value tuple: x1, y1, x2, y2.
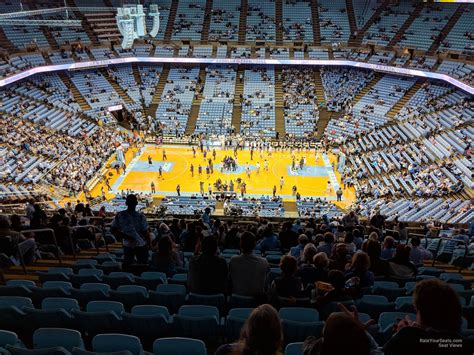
(111, 194, 151, 268)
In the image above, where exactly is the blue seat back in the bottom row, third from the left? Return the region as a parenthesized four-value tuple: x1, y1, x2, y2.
(92, 334, 143, 355)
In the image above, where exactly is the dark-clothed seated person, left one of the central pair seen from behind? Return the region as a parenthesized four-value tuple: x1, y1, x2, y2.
(188, 237, 228, 295)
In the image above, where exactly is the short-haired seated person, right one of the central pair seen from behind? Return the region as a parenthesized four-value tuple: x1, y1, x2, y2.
(229, 232, 270, 296)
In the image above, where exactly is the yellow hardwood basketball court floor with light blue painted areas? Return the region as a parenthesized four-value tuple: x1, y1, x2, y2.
(92, 145, 355, 207)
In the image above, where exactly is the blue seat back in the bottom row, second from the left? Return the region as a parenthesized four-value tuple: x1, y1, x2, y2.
(33, 328, 85, 351)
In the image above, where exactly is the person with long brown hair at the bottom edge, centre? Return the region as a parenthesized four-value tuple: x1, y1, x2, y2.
(215, 304, 283, 355)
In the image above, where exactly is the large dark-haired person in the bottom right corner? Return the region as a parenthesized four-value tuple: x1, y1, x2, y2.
(383, 280, 468, 355)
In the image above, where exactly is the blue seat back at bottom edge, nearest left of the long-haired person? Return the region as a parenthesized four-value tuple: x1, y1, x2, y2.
(153, 338, 207, 355)
